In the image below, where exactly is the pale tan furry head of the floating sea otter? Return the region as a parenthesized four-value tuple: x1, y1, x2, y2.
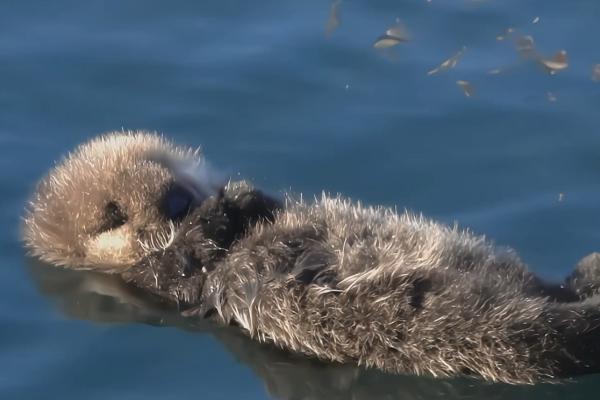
(23, 132, 217, 273)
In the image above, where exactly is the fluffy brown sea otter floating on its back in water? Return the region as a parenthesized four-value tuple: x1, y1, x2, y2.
(23, 132, 600, 383)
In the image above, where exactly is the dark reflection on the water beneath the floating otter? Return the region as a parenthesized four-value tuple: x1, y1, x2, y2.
(29, 260, 594, 400)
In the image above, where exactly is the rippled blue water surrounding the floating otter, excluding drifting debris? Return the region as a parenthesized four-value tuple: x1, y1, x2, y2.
(0, 0, 600, 399)
